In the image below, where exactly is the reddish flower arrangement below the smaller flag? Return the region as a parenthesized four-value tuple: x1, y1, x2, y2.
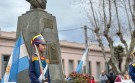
(69, 72, 89, 83)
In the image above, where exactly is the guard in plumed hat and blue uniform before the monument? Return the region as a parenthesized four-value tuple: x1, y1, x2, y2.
(29, 34, 50, 83)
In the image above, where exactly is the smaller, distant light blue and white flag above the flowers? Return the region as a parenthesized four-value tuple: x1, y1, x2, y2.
(76, 47, 89, 73)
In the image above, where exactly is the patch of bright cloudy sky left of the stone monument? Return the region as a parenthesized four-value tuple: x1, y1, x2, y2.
(0, 0, 28, 31)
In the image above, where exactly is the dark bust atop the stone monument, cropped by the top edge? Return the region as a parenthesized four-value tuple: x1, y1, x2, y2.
(26, 0, 47, 10)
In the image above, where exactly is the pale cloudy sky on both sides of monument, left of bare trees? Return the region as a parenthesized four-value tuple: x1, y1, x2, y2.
(0, 0, 87, 43)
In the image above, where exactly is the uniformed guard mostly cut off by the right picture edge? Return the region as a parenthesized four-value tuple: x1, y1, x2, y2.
(129, 51, 135, 83)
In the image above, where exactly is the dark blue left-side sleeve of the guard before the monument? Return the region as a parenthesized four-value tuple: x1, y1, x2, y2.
(29, 60, 41, 83)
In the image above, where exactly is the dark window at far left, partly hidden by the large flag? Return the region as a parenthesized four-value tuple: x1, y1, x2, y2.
(2, 55, 10, 77)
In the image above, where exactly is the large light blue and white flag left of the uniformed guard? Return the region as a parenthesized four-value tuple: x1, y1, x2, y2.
(1, 34, 29, 83)
